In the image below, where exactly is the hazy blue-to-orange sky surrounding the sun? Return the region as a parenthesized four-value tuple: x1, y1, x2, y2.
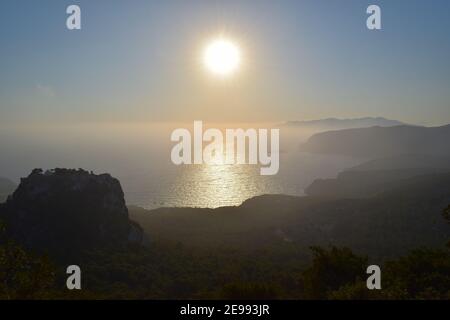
(0, 0, 450, 125)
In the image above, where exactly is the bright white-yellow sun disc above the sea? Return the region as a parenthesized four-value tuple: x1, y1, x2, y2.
(203, 38, 241, 77)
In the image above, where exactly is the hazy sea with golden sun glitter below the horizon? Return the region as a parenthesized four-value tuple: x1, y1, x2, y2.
(0, 123, 362, 209)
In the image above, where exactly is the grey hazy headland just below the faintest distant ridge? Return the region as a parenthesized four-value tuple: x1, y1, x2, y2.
(301, 125, 450, 158)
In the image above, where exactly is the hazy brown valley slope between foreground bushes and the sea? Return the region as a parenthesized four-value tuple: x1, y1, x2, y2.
(130, 174, 450, 257)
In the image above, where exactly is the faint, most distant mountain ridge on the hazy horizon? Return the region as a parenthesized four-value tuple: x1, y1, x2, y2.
(283, 117, 406, 130)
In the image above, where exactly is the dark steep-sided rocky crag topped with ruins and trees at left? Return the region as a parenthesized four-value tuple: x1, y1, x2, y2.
(0, 169, 142, 253)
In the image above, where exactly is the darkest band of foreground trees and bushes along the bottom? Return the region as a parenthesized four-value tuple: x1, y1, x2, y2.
(0, 207, 450, 299)
